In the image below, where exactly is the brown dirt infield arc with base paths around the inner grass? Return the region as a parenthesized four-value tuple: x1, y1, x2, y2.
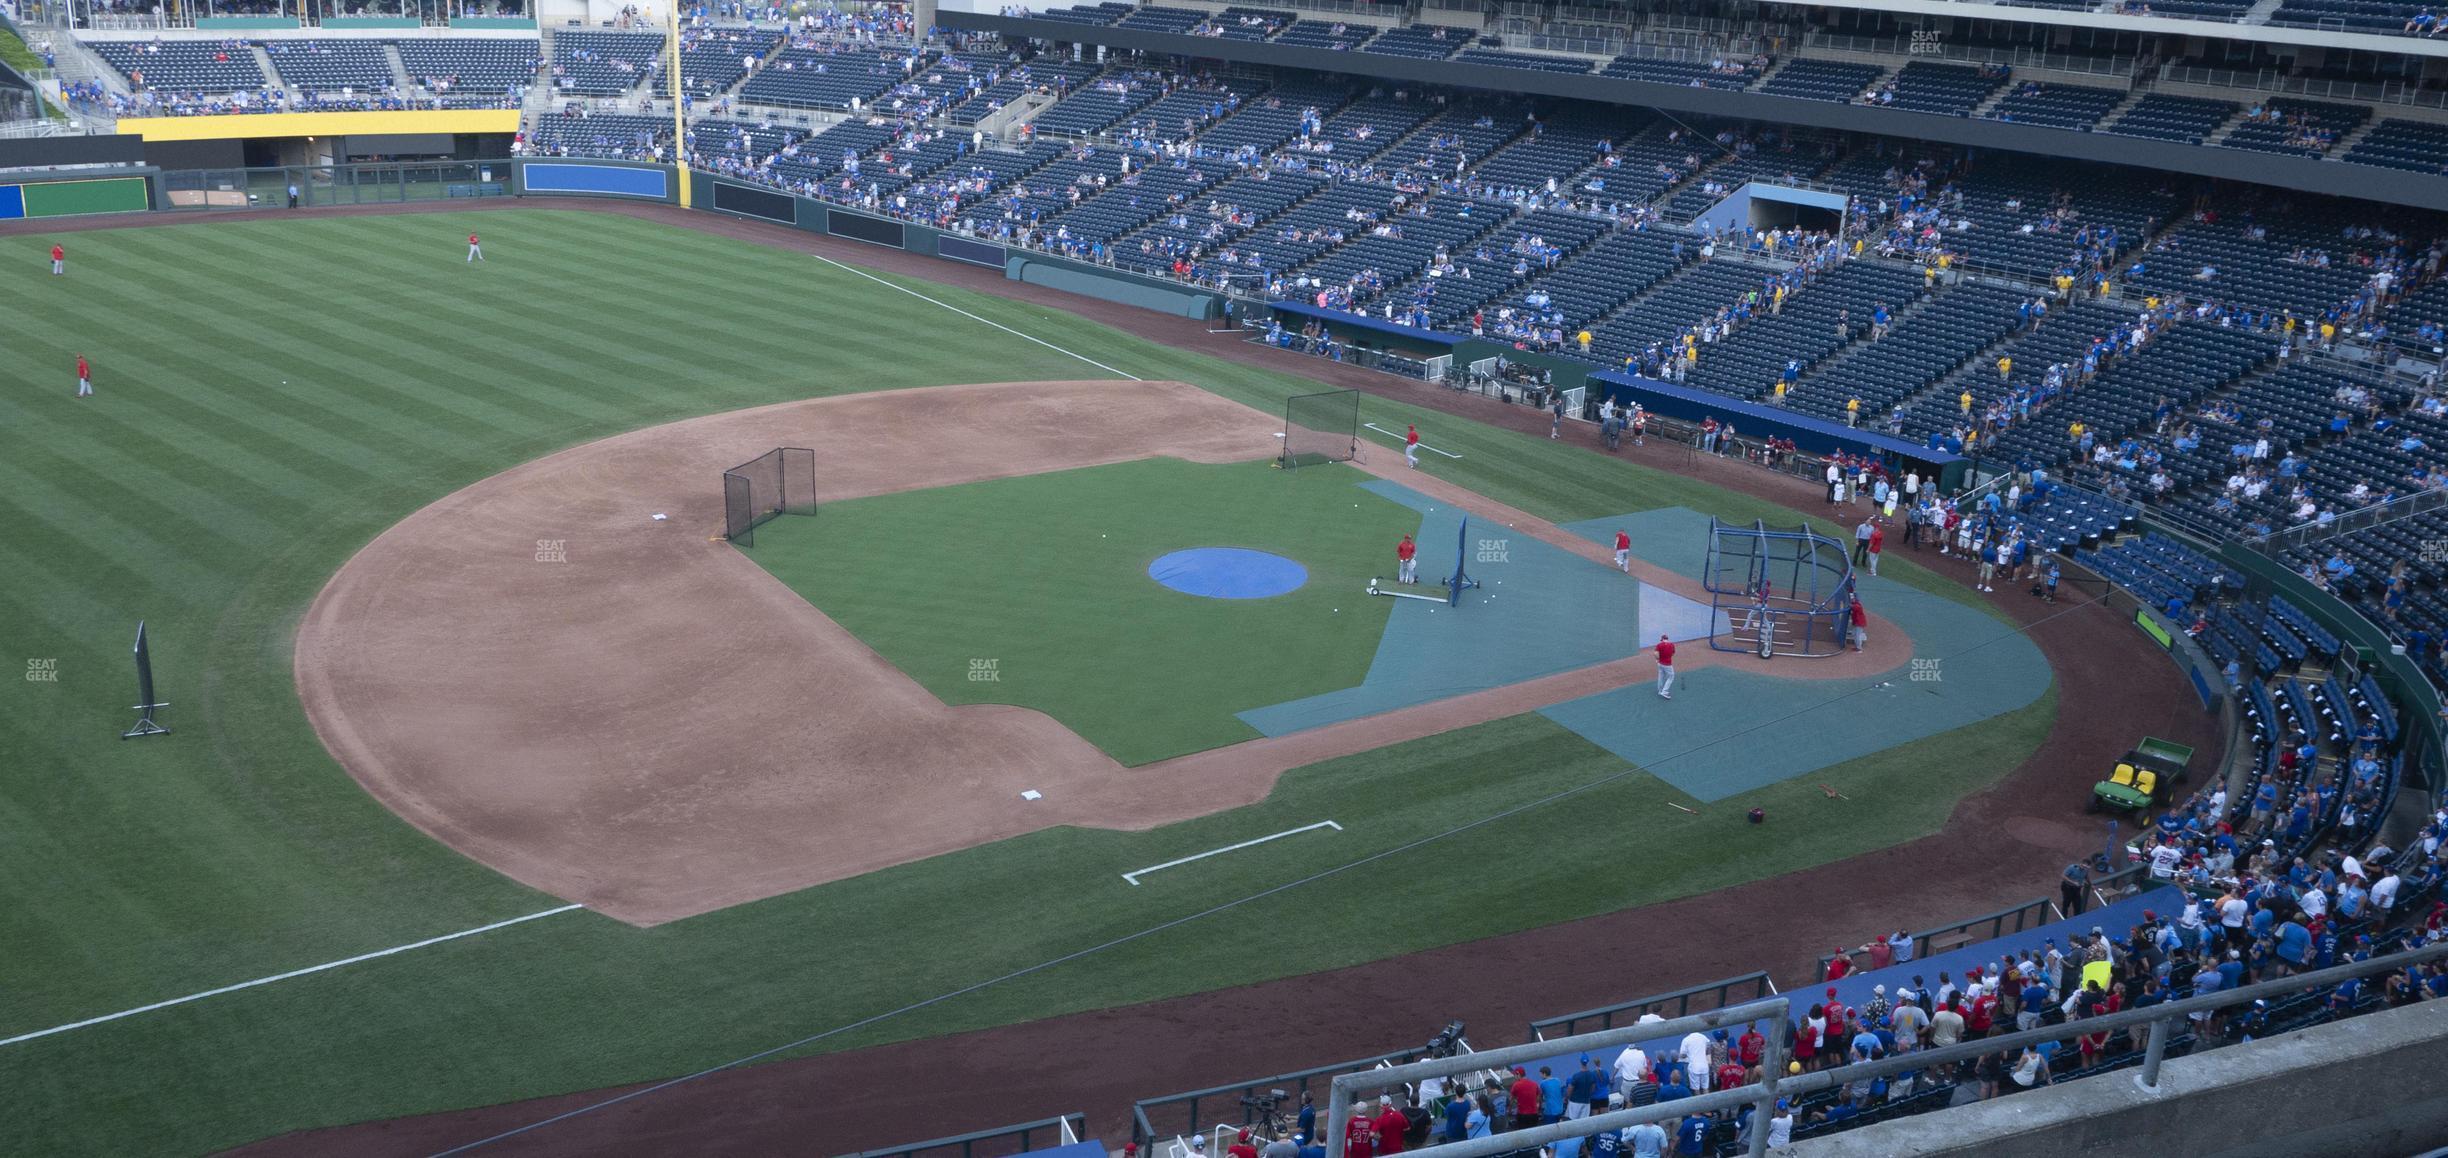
(296, 382, 1909, 925)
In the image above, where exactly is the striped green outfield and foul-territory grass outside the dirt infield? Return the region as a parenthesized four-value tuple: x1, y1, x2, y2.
(0, 211, 2054, 1153)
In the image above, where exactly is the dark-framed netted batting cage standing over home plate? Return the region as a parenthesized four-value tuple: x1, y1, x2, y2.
(1701, 519, 1853, 659)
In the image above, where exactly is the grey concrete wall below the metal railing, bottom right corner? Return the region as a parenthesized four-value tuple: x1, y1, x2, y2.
(1777, 1001, 2448, 1158)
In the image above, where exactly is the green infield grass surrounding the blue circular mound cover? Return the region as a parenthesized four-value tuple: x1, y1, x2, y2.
(749, 458, 1420, 764)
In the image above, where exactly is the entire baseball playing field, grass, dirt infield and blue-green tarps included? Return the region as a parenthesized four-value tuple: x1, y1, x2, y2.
(0, 208, 2056, 1153)
